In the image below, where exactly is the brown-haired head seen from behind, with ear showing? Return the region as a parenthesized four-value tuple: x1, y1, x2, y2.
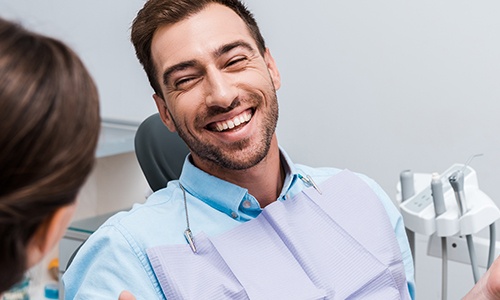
(0, 19, 100, 294)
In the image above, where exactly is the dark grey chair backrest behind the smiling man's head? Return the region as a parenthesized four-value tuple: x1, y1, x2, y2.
(134, 113, 189, 192)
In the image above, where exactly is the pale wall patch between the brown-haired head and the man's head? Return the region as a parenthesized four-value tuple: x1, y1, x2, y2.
(0, 0, 156, 121)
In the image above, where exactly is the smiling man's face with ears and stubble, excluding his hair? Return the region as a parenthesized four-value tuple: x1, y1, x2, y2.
(151, 4, 280, 171)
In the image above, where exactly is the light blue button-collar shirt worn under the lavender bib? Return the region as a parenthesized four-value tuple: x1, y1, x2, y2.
(63, 149, 414, 299)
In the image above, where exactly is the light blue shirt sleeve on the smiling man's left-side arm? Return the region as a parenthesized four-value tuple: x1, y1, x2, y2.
(62, 221, 165, 300)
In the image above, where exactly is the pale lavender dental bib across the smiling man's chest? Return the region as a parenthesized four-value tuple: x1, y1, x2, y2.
(147, 171, 410, 300)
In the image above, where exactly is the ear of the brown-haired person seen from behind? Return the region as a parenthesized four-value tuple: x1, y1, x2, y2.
(27, 201, 76, 267)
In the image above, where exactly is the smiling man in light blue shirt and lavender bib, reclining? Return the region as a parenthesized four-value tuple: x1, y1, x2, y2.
(64, 0, 414, 299)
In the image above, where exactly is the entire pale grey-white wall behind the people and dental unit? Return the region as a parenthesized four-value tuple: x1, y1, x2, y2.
(0, 0, 500, 299)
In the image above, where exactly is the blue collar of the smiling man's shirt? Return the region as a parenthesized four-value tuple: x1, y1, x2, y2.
(179, 147, 298, 220)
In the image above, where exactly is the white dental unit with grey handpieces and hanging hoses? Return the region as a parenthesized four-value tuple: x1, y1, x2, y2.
(397, 155, 500, 299)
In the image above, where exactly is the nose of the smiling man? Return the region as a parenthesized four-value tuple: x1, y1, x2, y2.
(205, 70, 238, 108)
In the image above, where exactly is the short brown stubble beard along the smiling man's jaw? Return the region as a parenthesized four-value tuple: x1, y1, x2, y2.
(173, 90, 279, 170)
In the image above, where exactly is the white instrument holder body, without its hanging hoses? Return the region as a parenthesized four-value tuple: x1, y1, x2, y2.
(397, 164, 500, 237)
